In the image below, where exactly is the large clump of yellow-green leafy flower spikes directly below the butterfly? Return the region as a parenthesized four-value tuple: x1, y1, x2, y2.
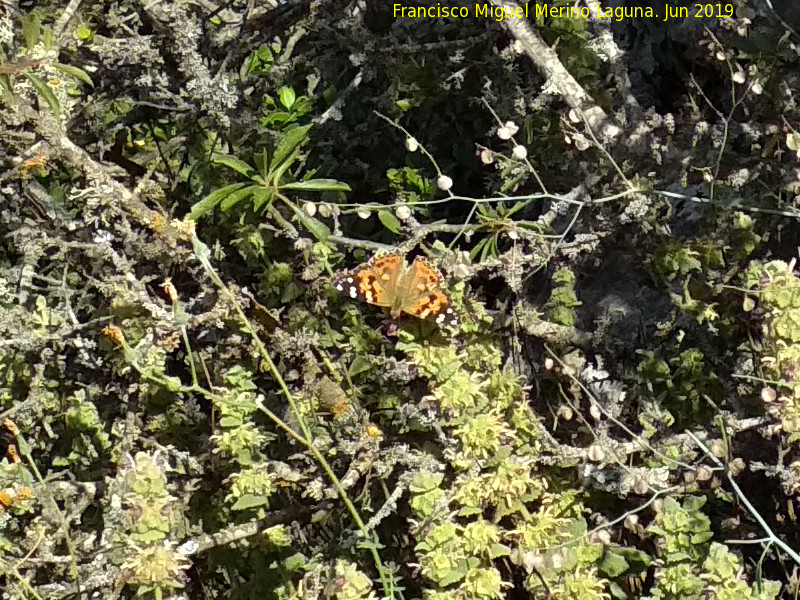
(404, 328, 608, 600)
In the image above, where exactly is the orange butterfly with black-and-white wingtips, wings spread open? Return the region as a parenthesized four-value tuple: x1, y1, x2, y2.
(333, 254, 458, 326)
